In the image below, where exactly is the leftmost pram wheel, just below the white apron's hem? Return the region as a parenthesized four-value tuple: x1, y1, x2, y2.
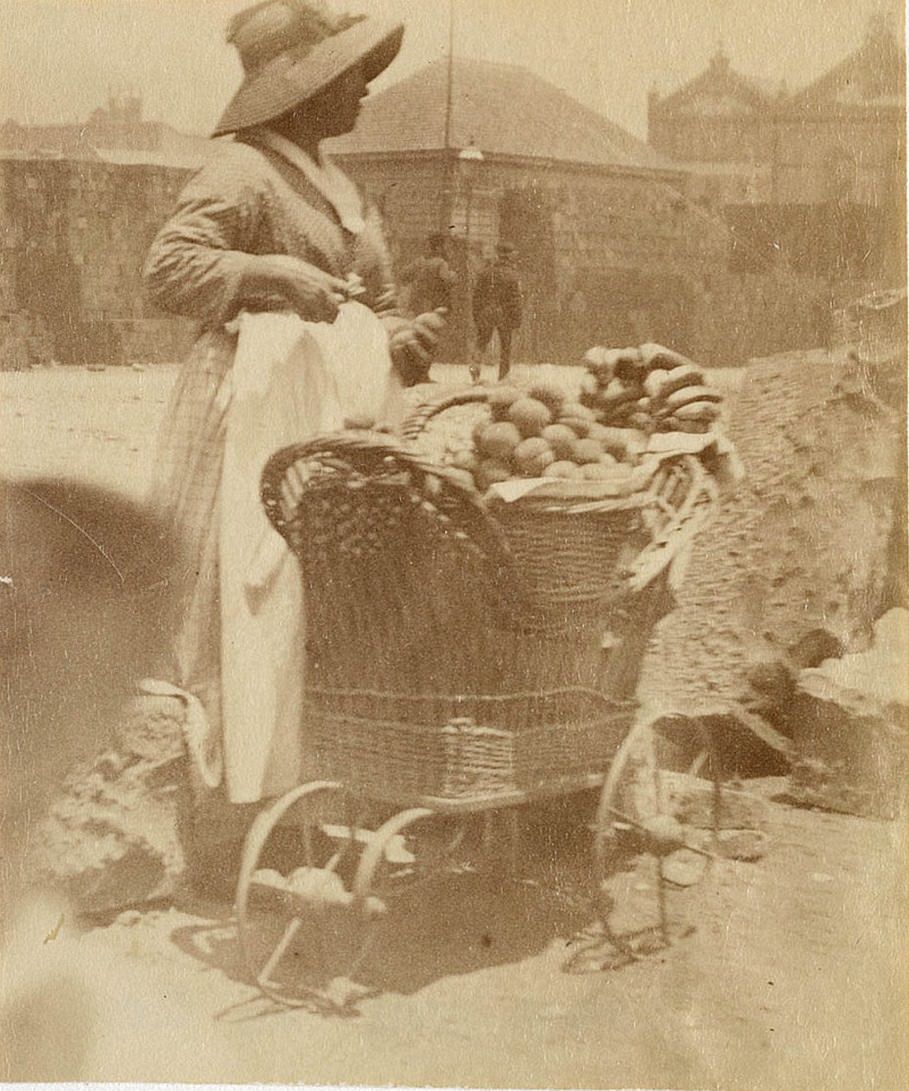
(236, 781, 383, 1007)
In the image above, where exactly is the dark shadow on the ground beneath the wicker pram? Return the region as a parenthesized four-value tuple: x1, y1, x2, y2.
(171, 820, 596, 1016)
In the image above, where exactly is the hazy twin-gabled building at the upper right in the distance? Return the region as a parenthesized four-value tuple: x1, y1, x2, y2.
(648, 16, 906, 288)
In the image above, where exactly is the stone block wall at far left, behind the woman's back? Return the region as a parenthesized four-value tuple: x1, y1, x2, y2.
(0, 159, 195, 367)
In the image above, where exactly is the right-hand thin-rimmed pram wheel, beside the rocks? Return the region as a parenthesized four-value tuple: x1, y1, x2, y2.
(595, 720, 721, 957)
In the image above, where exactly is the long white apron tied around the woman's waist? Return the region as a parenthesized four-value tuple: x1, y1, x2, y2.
(219, 302, 403, 803)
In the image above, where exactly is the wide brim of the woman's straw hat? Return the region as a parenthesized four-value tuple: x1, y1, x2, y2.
(212, 19, 404, 136)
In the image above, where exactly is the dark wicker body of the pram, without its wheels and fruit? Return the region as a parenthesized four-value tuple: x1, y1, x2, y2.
(262, 389, 716, 811)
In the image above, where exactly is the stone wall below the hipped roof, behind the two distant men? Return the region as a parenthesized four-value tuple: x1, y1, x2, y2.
(346, 155, 728, 361)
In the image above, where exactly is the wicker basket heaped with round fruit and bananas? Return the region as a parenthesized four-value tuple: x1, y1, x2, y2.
(405, 346, 722, 610)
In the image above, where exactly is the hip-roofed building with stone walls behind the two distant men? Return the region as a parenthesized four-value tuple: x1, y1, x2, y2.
(333, 58, 746, 360)
